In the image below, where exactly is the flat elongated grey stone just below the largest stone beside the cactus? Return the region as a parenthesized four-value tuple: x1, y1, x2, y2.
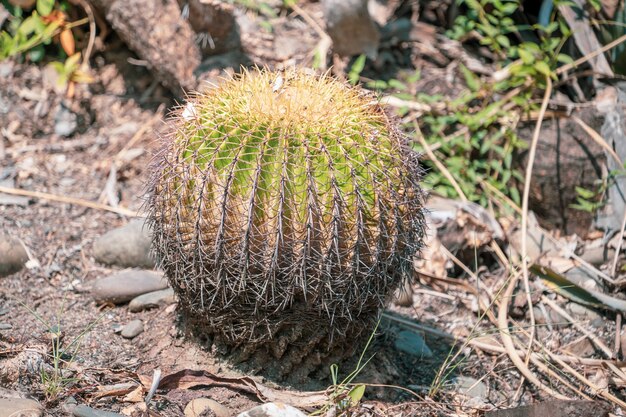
(91, 270, 167, 304)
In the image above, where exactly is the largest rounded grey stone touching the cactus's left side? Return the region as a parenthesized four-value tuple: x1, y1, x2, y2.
(93, 219, 155, 268)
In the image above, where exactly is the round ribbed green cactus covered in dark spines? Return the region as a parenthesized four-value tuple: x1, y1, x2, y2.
(148, 70, 424, 372)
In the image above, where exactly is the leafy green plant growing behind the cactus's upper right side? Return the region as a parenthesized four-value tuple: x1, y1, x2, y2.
(400, 0, 572, 205)
